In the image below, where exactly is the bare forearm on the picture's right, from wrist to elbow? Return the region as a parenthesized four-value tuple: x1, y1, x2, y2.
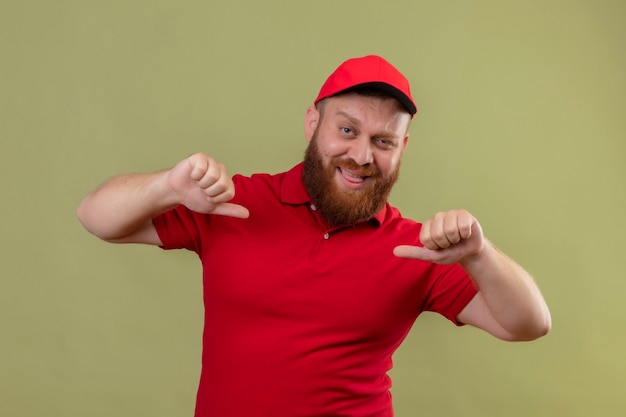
(461, 241, 551, 340)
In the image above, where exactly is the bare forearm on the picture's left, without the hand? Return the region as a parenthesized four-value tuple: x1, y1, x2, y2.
(77, 171, 177, 241)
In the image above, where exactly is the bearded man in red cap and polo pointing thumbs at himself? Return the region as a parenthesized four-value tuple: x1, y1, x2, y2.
(78, 56, 551, 417)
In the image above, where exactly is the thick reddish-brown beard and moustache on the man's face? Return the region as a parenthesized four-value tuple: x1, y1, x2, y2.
(302, 131, 400, 227)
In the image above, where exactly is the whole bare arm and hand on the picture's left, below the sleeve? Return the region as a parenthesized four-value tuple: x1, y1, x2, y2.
(77, 154, 250, 245)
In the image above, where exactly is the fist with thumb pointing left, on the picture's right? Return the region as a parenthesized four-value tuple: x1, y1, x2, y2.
(393, 210, 485, 264)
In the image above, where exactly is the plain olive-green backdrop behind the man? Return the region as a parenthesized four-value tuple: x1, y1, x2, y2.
(0, 0, 626, 417)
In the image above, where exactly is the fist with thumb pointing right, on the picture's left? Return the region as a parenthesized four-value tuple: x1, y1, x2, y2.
(167, 153, 250, 219)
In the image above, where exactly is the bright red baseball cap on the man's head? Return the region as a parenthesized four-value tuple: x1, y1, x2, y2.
(314, 55, 417, 117)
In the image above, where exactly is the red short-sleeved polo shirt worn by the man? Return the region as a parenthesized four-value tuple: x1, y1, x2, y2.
(154, 164, 476, 417)
